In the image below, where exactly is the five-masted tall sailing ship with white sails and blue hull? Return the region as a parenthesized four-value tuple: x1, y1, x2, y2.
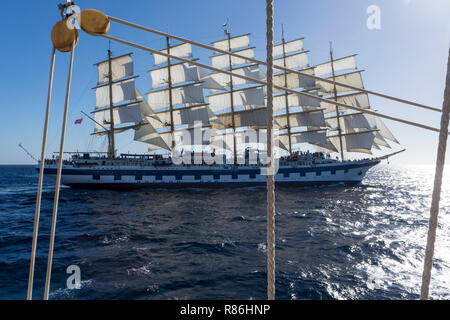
(44, 31, 399, 188)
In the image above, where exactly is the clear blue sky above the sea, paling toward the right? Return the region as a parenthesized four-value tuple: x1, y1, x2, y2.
(0, 0, 450, 165)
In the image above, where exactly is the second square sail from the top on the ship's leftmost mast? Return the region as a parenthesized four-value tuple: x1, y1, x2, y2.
(95, 79, 136, 109)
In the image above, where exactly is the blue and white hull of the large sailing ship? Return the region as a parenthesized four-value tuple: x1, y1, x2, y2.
(39, 160, 380, 189)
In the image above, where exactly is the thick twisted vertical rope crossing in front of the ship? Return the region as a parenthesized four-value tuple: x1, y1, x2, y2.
(266, 0, 275, 300)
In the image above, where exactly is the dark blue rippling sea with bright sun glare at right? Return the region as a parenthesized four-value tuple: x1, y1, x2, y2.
(0, 165, 450, 299)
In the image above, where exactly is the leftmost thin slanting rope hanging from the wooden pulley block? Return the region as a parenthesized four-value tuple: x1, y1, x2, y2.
(27, 47, 56, 300)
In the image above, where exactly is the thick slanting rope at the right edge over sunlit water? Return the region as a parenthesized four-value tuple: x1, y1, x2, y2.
(420, 47, 450, 300)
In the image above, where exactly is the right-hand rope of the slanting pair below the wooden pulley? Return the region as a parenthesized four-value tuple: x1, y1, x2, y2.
(44, 41, 75, 300)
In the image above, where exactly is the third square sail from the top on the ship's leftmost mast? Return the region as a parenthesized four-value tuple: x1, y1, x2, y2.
(94, 104, 142, 131)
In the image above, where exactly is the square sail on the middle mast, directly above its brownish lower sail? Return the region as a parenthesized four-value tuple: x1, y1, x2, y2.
(208, 87, 265, 112)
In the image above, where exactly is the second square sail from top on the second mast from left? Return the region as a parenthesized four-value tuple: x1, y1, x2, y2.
(150, 63, 200, 89)
